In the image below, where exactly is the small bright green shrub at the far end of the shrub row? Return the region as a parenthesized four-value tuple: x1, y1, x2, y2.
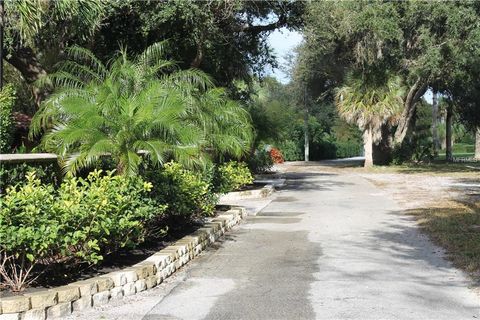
(214, 161, 255, 193)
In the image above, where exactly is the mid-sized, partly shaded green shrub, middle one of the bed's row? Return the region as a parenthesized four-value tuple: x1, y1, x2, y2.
(143, 162, 218, 220)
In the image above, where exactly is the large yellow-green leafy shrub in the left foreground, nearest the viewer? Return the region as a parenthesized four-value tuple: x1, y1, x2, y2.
(0, 171, 165, 291)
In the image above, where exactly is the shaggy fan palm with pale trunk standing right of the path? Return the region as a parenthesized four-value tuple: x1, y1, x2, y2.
(335, 75, 402, 167)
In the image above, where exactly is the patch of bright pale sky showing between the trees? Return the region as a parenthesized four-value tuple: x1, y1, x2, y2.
(266, 28, 302, 83)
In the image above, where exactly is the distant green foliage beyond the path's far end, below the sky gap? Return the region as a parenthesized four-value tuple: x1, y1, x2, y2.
(247, 78, 362, 162)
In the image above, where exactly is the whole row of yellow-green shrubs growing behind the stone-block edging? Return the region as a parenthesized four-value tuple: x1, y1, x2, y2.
(0, 161, 253, 291)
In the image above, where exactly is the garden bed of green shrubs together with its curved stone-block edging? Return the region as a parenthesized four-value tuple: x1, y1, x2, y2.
(0, 158, 253, 319)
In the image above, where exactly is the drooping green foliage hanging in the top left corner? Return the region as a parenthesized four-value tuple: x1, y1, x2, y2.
(4, 0, 107, 107)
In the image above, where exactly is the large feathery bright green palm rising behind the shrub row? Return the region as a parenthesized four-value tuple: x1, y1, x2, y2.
(31, 42, 248, 175)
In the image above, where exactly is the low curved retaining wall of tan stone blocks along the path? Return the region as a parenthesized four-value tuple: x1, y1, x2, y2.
(0, 207, 247, 320)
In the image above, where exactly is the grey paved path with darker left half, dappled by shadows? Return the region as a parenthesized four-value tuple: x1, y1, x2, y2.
(72, 167, 480, 320)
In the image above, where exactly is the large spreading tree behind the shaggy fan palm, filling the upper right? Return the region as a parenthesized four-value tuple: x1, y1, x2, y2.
(293, 1, 480, 162)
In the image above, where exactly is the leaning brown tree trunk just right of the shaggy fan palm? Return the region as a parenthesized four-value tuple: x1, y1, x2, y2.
(393, 78, 427, 147)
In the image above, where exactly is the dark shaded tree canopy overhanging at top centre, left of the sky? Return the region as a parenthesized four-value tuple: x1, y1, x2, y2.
(92, 0, 305, 87)
